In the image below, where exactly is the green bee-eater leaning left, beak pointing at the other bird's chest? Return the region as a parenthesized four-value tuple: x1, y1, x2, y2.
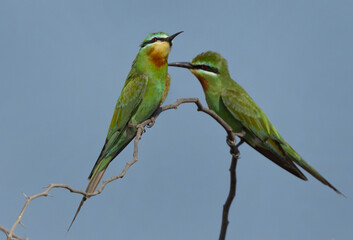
(169, 51, 341, 194)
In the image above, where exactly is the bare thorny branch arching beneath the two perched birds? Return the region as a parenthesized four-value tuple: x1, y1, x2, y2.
(0, 98, 244, 240)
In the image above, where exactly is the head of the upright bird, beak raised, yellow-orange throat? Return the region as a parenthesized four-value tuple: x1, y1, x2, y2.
(140, 31, 183, 68)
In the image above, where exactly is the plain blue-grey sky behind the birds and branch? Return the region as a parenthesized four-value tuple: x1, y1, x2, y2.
(0, 0, 353, 240)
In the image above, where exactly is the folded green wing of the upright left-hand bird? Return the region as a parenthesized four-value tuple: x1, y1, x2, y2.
(89, 74, 148, 179)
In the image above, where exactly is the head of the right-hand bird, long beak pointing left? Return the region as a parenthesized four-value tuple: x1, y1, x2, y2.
(168, 51, 229, 91)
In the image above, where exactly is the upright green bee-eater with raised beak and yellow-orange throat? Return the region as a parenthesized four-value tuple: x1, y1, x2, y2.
(69, 32, 182, 229)
